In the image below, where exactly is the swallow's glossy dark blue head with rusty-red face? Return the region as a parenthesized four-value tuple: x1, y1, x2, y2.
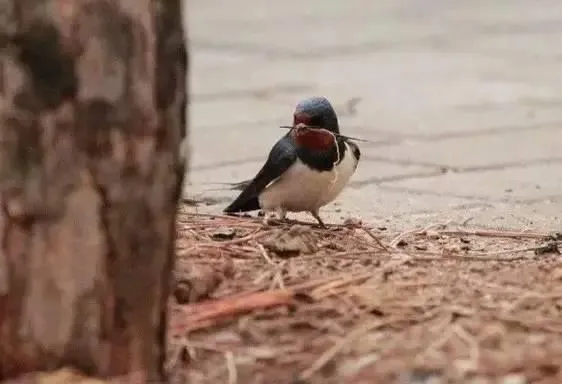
(293, 96, 340, 133)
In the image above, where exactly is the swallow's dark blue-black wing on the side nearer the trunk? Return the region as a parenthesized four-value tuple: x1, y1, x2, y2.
(224, 134, 297, 213)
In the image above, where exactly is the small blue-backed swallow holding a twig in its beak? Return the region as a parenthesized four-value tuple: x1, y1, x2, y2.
(223, 96, 361, 227)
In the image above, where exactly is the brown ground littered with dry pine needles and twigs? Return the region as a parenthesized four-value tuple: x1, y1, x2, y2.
(168, 207, 562, 384)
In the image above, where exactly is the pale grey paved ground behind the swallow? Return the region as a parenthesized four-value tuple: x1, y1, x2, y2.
(182, 0, 562, 230)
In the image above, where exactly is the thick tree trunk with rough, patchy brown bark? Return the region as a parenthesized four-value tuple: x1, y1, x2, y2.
(0, 0, 187, 381)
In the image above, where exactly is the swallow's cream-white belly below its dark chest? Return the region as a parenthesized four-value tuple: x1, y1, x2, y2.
(259, 147, 357, 212)
